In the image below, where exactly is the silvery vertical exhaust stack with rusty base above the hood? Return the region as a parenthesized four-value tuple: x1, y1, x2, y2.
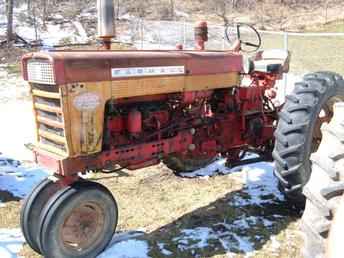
(97, 0, 115, 50)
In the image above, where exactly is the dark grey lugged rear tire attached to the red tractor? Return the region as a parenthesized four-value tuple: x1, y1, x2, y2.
(272, 72, 344, 209)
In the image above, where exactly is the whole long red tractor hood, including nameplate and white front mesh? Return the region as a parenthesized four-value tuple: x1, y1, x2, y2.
(22, 50, 243, 85)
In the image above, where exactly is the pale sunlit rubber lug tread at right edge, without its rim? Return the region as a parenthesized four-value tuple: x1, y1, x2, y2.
(301, 103, 344, 258)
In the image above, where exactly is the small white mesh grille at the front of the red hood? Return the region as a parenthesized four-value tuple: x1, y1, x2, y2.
(27, 59, 55, 85)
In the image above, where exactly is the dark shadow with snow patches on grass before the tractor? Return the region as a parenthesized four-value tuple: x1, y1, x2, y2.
(144, 188, 299, 258)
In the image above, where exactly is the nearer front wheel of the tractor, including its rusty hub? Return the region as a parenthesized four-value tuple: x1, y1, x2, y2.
(39, 182, 118, 258)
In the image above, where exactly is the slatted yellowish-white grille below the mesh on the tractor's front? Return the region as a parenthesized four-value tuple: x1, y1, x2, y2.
(31, 83, 68, 155)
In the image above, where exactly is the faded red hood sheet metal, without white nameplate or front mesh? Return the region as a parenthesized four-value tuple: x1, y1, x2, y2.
(23, 50, 242, 84)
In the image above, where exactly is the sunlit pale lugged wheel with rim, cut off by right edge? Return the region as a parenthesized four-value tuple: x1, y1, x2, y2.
(301, 102, 344, 258)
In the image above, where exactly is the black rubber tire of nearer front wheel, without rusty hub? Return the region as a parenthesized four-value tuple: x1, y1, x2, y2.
(40, 183, 118, 258)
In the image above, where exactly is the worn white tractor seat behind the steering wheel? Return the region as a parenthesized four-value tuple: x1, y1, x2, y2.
(253, 49, 290, 74)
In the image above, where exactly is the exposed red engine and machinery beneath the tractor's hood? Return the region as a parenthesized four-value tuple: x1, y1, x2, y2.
(103, 87, 275, 162)
